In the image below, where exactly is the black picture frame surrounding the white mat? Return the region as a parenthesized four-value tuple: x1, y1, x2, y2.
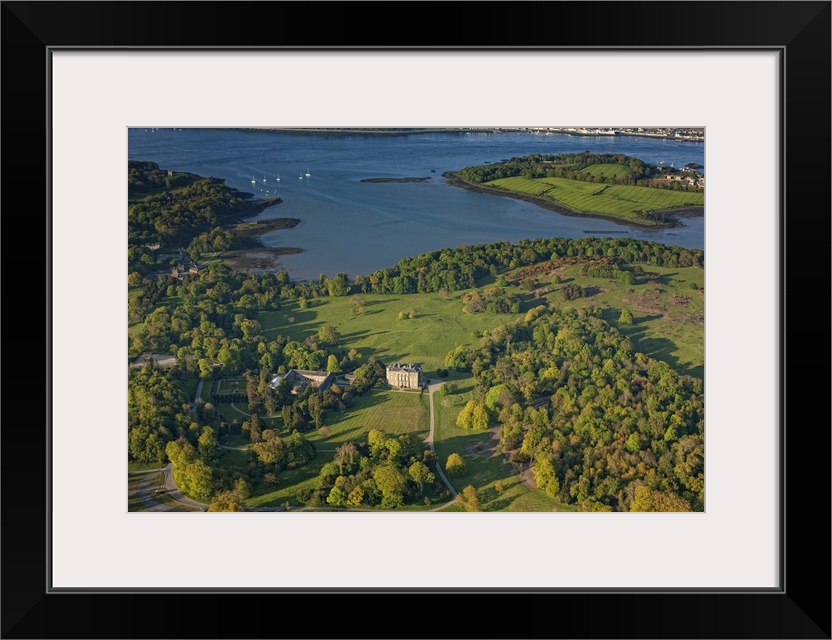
(0, 2, 832, 638)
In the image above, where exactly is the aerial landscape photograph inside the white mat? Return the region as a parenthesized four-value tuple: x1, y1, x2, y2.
(125, 125, 704, 518)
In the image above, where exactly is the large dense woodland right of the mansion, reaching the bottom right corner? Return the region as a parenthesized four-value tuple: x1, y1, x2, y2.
(442, 306, 704, 511)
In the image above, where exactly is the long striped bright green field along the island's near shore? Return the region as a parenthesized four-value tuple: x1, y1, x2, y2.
(485, 176, 705, 224)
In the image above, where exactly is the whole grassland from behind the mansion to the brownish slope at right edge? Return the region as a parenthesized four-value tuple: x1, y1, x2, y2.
(258, 265, 705, 378)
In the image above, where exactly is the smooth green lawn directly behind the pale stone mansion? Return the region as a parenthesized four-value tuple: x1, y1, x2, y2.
(259, 291, 525, 377)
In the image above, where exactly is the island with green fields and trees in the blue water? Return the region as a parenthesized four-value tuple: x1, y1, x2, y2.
(443, 151, 705, 228)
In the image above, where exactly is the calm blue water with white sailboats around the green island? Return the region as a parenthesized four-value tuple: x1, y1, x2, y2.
(129, 128, 705, 279)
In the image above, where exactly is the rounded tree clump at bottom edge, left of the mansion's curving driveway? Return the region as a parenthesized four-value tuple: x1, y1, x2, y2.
(297, 429, 443, 509)
